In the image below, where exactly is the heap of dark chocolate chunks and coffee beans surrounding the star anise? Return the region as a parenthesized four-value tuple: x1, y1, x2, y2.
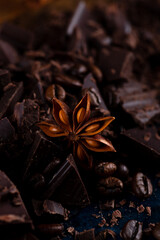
(0, 0, 160, 240)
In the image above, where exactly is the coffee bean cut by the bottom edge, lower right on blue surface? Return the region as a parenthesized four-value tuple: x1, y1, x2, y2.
(120, 220, 142, 240)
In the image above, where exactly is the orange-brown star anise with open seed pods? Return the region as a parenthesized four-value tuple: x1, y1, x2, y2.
(38, 93, 115, 168)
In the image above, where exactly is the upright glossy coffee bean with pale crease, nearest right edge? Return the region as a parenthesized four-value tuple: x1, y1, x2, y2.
(132, 173, 153, 198)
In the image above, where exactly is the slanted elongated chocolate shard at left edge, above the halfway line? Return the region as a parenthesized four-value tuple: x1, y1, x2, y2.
(0, 82, 23, 119)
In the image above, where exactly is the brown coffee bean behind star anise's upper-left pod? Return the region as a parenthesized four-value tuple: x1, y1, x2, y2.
(45, 84, 66, 102)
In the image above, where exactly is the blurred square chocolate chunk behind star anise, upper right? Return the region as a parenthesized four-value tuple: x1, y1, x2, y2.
(99, 48, 134, 81)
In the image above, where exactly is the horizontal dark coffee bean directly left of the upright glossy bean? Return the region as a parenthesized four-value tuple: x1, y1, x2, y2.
(97, 177, 123, 196)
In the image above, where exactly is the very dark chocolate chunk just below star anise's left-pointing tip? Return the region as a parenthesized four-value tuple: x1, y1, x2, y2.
(24, 132, 59, 178)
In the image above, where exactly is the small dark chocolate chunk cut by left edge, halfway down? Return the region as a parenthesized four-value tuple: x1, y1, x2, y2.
(0, 117, 15, 144)
